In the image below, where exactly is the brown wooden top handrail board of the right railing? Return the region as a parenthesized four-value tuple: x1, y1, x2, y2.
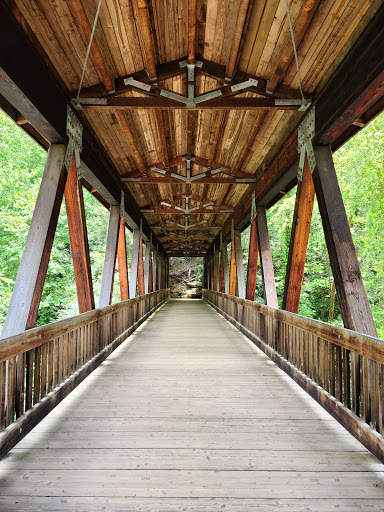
(203, 289, 384, 364)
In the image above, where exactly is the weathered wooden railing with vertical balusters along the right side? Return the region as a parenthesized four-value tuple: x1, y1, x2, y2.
(203, 290, 384, 462)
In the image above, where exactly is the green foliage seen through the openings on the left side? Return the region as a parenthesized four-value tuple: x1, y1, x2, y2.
(0, 111, 119, 325)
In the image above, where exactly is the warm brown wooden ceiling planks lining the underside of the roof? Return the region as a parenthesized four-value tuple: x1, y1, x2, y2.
(8, 0, 380, 255)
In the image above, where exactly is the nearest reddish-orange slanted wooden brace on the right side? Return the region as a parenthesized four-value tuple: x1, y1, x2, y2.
(282, 158, 315, 313)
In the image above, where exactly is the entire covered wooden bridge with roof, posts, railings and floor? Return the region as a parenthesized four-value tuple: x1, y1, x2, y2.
(0, 0, 384, 511)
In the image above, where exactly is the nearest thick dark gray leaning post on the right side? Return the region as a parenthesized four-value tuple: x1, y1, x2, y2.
(313, 146, 377, 336)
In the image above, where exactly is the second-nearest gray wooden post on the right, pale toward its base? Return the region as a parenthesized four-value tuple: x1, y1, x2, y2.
(256, 206, 279, 308)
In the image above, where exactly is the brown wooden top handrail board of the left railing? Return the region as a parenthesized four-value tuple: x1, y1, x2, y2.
(0, 288, 168, 363)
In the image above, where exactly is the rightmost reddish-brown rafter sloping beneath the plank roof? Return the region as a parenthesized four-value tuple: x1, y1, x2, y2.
(267, 0, 320, 94)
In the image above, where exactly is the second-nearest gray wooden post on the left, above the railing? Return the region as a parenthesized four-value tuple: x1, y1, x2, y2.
(99, 206, 120, 308)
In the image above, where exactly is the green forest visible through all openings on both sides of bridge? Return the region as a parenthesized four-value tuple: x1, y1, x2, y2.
(0, 111, 384, 338)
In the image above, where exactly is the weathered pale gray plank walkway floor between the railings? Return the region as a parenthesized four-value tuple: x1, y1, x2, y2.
(0, 300, 384, 512)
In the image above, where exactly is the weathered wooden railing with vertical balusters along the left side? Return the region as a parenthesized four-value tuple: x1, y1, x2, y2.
(0, 289, 169, 458)
